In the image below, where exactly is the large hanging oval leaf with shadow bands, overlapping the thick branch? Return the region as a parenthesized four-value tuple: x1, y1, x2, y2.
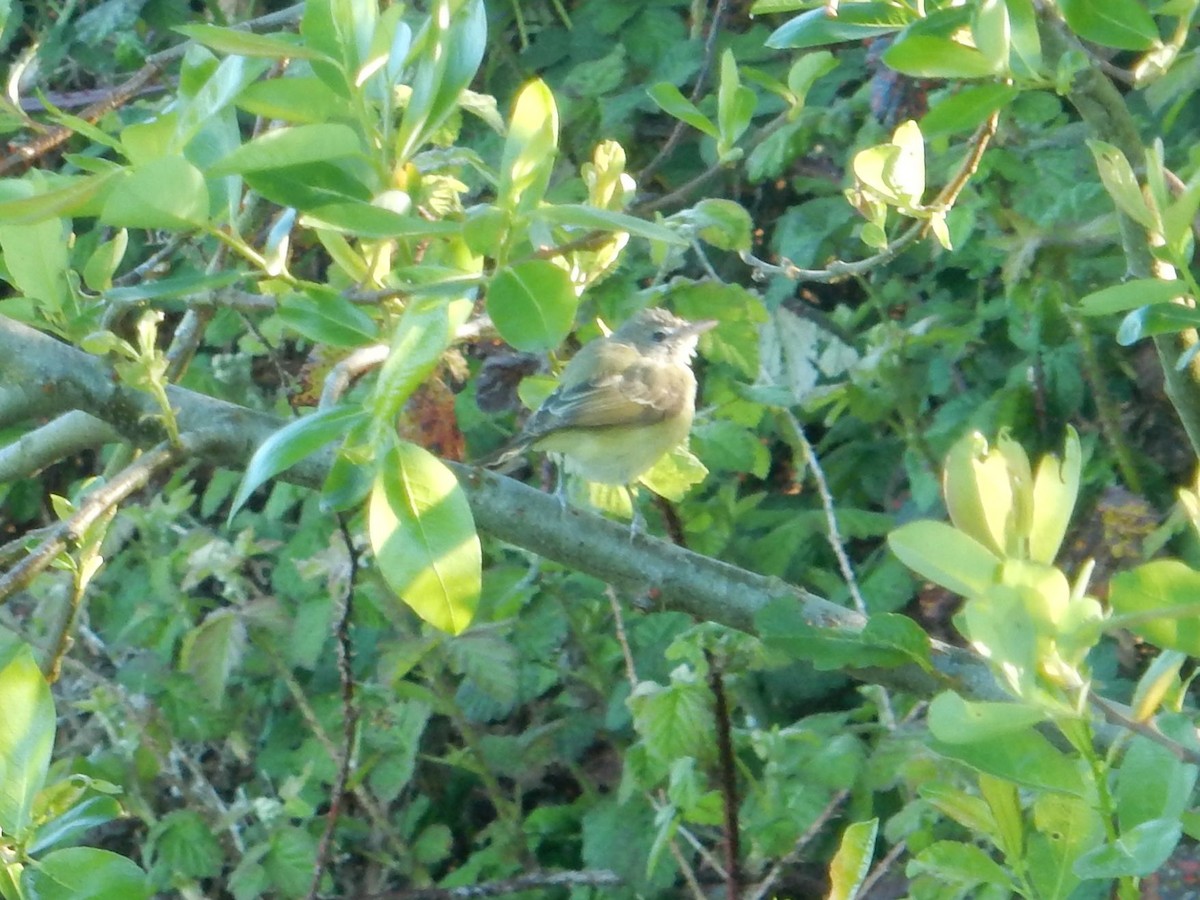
(367, 442, 482, 635)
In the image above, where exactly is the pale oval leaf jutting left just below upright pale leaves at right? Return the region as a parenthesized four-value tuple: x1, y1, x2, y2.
(888, 521, 1000, 596)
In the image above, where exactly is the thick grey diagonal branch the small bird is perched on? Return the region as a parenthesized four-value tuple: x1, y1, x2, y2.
(0, 317, 1000, 698)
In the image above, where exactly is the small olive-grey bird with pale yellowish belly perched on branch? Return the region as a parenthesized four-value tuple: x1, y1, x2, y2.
(484, 308, 716, 487)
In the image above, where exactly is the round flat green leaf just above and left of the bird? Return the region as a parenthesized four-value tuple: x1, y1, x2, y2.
(487, 259, 578, 353)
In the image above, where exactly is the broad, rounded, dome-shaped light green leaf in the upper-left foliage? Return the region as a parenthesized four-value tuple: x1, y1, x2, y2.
(100, 156, 209, 230)
